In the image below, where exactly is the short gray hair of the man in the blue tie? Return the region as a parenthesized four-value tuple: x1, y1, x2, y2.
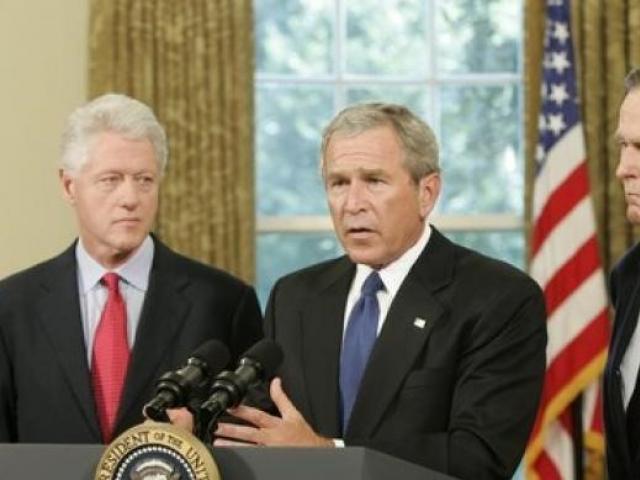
(320, 103, 440, 183)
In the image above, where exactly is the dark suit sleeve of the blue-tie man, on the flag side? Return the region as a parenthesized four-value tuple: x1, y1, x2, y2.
(348, 282, 547, 479)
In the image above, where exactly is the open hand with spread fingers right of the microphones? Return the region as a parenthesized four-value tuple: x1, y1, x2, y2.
(213, 378, 334, 447)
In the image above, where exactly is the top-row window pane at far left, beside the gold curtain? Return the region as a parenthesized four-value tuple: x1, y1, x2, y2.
(254, 0, 334, 75)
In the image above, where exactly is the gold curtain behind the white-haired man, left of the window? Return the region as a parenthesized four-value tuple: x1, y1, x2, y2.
(89, 0, 255, 281)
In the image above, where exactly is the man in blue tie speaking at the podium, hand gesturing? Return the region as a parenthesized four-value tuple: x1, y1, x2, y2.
(209, 104, 546, 479)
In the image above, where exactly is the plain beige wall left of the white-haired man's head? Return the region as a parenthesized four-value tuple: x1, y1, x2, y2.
(0, 0, 88, 278)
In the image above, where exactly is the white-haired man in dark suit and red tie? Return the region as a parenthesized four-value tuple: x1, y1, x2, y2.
(0, 94, 262, 443)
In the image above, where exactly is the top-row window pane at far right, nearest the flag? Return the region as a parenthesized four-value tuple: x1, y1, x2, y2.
(436, 0, 523, 73)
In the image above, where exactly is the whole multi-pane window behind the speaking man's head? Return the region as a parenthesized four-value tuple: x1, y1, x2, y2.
(255, 0, 524, 305)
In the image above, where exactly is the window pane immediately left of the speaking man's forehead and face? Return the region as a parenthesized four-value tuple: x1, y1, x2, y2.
(256, 85, 333, 215)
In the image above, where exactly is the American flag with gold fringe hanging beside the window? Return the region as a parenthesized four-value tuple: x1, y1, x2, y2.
(525, 0, 609, 480)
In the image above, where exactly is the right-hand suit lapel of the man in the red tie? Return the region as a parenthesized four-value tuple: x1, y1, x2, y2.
(116, 239, 191, 429)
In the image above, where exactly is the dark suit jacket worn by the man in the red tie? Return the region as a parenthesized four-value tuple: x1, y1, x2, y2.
(0, 239, 262, 443)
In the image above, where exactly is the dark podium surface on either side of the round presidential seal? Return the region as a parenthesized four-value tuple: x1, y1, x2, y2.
(0, 444, 460, 480)
